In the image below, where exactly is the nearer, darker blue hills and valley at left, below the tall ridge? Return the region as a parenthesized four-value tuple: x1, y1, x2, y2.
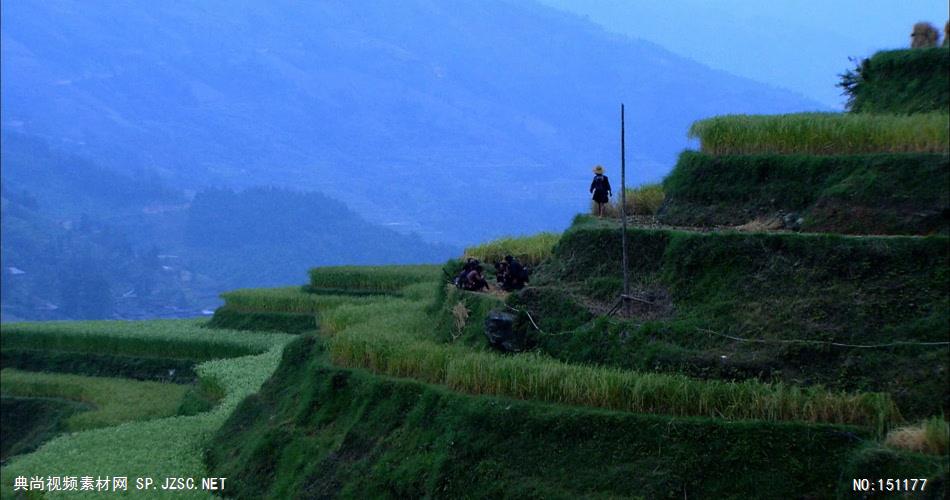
(0, 134, 459, 321)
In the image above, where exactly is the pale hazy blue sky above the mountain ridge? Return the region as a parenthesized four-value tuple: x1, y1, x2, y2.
(540, 0, 950, 108)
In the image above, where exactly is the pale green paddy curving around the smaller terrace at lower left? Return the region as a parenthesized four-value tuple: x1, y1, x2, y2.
(0, 321, 294, 498)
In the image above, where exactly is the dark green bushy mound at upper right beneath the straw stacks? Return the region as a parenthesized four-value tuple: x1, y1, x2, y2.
(839, 47, 950, 113)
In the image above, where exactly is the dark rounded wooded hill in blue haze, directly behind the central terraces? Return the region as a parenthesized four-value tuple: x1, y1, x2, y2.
(183, 188, 461, 287)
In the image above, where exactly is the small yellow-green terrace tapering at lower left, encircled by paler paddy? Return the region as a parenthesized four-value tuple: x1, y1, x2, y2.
(0, 369, 188, 432)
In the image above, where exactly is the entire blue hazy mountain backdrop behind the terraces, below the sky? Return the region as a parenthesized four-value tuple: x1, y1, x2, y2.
(0, 0, 905, 320)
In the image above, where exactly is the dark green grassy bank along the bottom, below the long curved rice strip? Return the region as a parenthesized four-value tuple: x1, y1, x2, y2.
(207, 336, 942, 499)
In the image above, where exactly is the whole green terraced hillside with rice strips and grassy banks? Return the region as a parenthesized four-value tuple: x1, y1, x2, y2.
(0, 49, 950, 499)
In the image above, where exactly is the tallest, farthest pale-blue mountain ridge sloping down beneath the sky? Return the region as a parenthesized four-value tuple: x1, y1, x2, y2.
(0, 0, 821, 243)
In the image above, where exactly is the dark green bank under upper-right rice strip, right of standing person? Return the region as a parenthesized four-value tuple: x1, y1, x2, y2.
(659, 151, 950, 234)
